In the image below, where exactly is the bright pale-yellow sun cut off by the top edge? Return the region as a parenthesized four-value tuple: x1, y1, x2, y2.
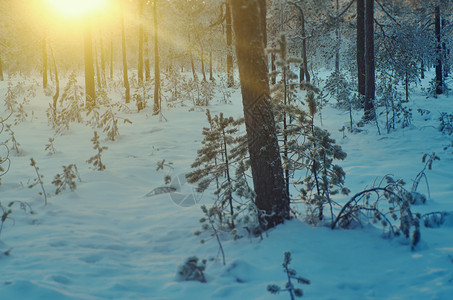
(47, 0, 108, 18)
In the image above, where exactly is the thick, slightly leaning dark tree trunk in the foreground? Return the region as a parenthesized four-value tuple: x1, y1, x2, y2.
(231, 0, 290, 229)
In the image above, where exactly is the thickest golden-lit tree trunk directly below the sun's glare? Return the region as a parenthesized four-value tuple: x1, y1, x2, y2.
(84, 22, 96, 109)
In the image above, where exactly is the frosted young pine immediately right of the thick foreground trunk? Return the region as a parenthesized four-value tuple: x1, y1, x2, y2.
(286, 91, 350, 224)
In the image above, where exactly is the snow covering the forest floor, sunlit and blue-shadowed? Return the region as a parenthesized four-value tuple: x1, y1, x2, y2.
(0, 73, 453, 300)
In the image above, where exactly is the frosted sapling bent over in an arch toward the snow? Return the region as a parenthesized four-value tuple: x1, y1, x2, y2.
(332, 175, 421, 249)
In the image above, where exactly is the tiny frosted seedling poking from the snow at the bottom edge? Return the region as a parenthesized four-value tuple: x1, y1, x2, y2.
(267, 251, 310, 300)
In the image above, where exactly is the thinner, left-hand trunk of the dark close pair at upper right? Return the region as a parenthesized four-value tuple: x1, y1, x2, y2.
(357, 0, 365, 96)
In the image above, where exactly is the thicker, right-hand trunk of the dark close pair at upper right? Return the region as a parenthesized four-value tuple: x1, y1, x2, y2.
(364, 0, 375, 121)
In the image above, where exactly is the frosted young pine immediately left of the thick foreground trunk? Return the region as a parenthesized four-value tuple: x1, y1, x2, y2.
(186, 110, 252, 229)
